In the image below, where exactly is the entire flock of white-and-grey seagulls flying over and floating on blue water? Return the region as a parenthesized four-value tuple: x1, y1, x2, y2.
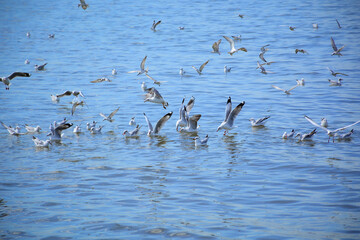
(0, 0, 360, 147)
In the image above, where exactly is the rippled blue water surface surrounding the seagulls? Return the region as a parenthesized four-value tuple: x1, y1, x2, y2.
(0, 0, 360, 239)
